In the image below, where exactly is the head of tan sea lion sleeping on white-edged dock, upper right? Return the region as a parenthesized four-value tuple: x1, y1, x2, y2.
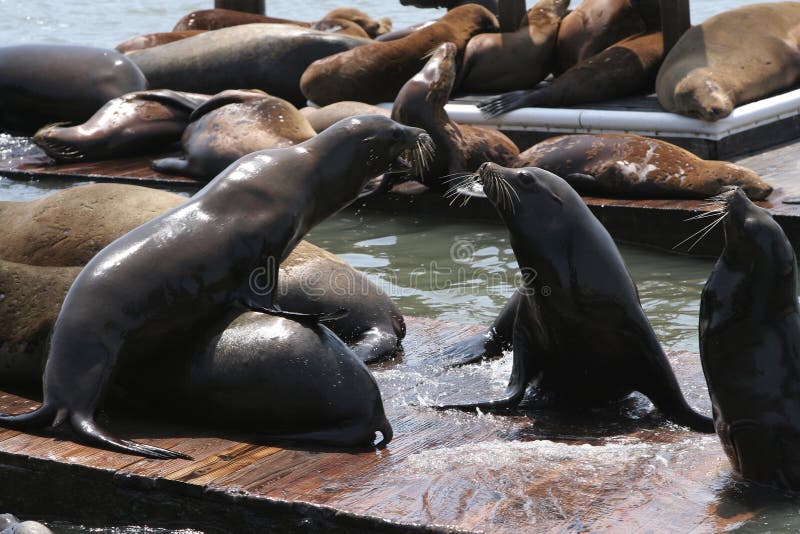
(675, 69, 733, 121)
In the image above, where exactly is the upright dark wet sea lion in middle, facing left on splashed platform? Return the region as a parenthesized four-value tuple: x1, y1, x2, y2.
(439, 163, 713, 432)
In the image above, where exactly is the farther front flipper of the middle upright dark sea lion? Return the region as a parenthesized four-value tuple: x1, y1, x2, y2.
(444, 290, 521, 367)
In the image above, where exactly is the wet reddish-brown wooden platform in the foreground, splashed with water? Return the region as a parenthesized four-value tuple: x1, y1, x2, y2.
(0, 319, 792, 533)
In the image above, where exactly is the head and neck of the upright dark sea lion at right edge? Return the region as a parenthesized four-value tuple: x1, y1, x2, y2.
(715, 187, 797, 298)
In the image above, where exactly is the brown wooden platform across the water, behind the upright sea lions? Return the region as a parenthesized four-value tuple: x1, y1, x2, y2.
(0, 136, 800, 256)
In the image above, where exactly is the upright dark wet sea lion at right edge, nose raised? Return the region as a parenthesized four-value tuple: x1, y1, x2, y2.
(700, 189, 800, 491)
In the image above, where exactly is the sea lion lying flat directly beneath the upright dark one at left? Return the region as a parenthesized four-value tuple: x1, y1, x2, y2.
(0, 262, 392, 447)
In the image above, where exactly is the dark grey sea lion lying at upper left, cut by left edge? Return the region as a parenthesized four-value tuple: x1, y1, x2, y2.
(0, 44, 147, 135)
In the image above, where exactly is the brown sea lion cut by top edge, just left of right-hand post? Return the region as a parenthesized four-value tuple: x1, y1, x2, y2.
(555, 0, 661, 75)
